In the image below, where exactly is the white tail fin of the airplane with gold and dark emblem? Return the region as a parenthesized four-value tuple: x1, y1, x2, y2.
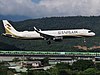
(3, 20, 17, 34)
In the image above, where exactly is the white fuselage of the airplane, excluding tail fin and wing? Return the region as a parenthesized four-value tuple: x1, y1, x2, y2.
(13, 29, 95, 39)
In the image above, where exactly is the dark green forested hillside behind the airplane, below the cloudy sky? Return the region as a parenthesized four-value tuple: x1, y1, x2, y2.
(0, 16, 100, 51)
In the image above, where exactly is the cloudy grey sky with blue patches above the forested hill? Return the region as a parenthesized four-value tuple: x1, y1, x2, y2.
(0, 0, 100, 18)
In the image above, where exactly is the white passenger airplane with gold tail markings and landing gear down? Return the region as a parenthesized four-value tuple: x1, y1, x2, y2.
(3, 20, 95, 44)
